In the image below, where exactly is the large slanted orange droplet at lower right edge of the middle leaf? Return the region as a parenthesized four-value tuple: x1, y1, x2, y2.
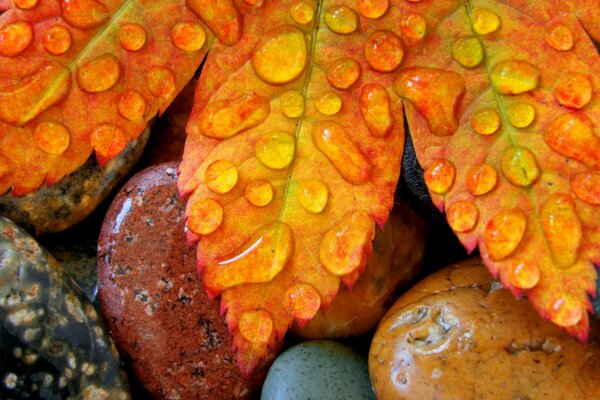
(319, 210, 375, 276)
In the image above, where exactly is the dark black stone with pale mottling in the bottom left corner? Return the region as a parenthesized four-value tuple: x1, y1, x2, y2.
(0, 217, 130, 399)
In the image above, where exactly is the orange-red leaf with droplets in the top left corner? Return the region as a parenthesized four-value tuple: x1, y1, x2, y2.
(0, 0, 223, 196)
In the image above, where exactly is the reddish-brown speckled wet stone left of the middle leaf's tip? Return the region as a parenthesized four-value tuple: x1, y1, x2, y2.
(98, 163, 274, 399)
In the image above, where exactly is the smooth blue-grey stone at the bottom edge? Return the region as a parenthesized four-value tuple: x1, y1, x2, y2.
(261, 340, 375, 400)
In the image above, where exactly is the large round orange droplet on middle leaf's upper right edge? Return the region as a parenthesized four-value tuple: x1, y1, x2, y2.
(365, 30, 404, 72)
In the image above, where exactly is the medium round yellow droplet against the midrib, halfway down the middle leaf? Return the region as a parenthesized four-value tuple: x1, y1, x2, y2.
(254, 131, 296, 169)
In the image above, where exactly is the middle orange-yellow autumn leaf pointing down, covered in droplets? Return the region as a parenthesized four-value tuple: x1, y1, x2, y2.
(178, 0, 403, 374)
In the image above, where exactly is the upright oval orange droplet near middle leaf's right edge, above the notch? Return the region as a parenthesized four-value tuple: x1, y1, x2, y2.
(359, 83, 393, 137)
